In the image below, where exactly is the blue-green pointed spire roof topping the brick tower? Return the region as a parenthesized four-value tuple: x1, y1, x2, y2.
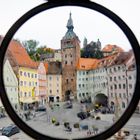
(63, 12, 77, 39)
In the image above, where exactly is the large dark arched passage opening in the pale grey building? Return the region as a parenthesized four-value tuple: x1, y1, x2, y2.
(94, 93, 108, 107)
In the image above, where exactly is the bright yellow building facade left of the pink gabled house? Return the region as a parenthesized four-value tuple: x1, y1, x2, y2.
(19, 67, 39, 103)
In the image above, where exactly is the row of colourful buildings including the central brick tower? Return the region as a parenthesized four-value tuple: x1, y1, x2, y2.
(0, 13, 139, 114)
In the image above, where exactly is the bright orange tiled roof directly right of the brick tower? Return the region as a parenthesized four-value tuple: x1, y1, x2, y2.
(77, 58, 99, 70)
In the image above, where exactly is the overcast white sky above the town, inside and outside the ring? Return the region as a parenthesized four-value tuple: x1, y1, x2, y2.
(0, 0, 140, 51)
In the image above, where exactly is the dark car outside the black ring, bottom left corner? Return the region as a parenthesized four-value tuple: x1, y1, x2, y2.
(2, 125, 20, 137)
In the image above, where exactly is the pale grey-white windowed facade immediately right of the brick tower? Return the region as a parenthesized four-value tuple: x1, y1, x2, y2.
(77, 68, 108, 101)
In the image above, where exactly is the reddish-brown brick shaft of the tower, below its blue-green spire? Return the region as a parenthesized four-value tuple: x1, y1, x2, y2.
(61, 38, 80, 100)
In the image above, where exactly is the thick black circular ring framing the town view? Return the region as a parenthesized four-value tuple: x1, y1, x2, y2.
(0, 0, 140, 140)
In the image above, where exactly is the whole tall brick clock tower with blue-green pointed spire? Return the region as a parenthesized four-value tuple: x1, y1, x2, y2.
(61, 13, 80, 100)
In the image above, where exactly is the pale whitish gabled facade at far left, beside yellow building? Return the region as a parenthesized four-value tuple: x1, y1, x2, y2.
(4, 59, 19, 108)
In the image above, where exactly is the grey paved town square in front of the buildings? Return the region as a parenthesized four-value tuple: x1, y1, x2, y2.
(0, 103, 140, 140)
